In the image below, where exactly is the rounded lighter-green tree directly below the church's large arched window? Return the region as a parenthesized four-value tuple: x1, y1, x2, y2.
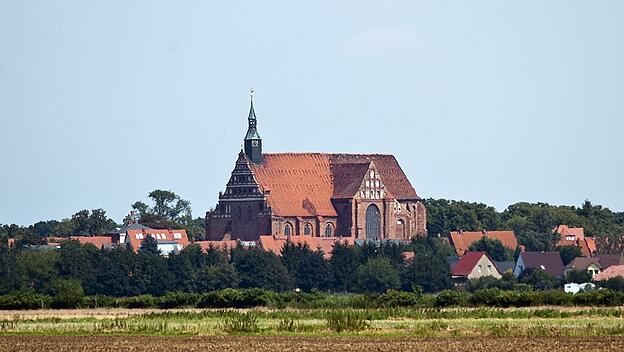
(356, 258, 401, 293)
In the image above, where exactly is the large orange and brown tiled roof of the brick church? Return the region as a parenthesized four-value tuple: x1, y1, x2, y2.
(250, 153, 420, 216)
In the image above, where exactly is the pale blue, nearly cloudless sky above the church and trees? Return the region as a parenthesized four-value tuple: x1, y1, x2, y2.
(0, 0, 624, 225)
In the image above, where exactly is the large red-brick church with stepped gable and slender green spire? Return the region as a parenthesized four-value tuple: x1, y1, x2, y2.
(206, 98, 426, 241)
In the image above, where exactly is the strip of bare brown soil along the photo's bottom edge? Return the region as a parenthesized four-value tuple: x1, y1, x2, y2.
(0, 336, 624, 352)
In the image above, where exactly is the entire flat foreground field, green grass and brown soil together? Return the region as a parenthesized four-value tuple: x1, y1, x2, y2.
(0, 307, 624, 352)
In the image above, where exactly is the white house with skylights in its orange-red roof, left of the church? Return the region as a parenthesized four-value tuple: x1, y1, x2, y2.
(125, 228, 190, 256)
